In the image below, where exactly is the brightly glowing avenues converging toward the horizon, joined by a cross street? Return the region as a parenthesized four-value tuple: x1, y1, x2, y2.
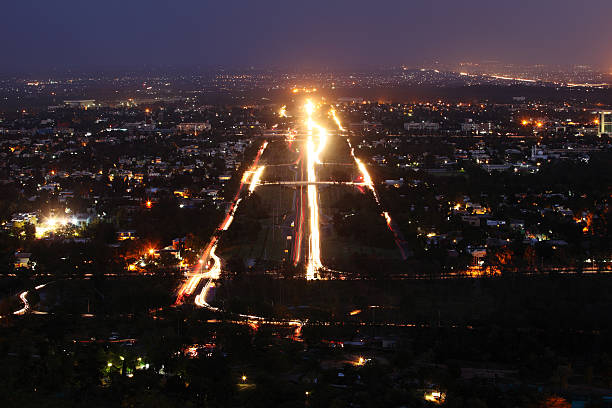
(176, 100, 406, 320)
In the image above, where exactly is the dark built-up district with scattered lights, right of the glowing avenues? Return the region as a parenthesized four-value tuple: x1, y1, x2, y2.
(337, 98, 612, 273)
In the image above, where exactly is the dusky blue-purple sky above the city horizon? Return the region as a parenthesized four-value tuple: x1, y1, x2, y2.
(0, 0, 612, 72)
